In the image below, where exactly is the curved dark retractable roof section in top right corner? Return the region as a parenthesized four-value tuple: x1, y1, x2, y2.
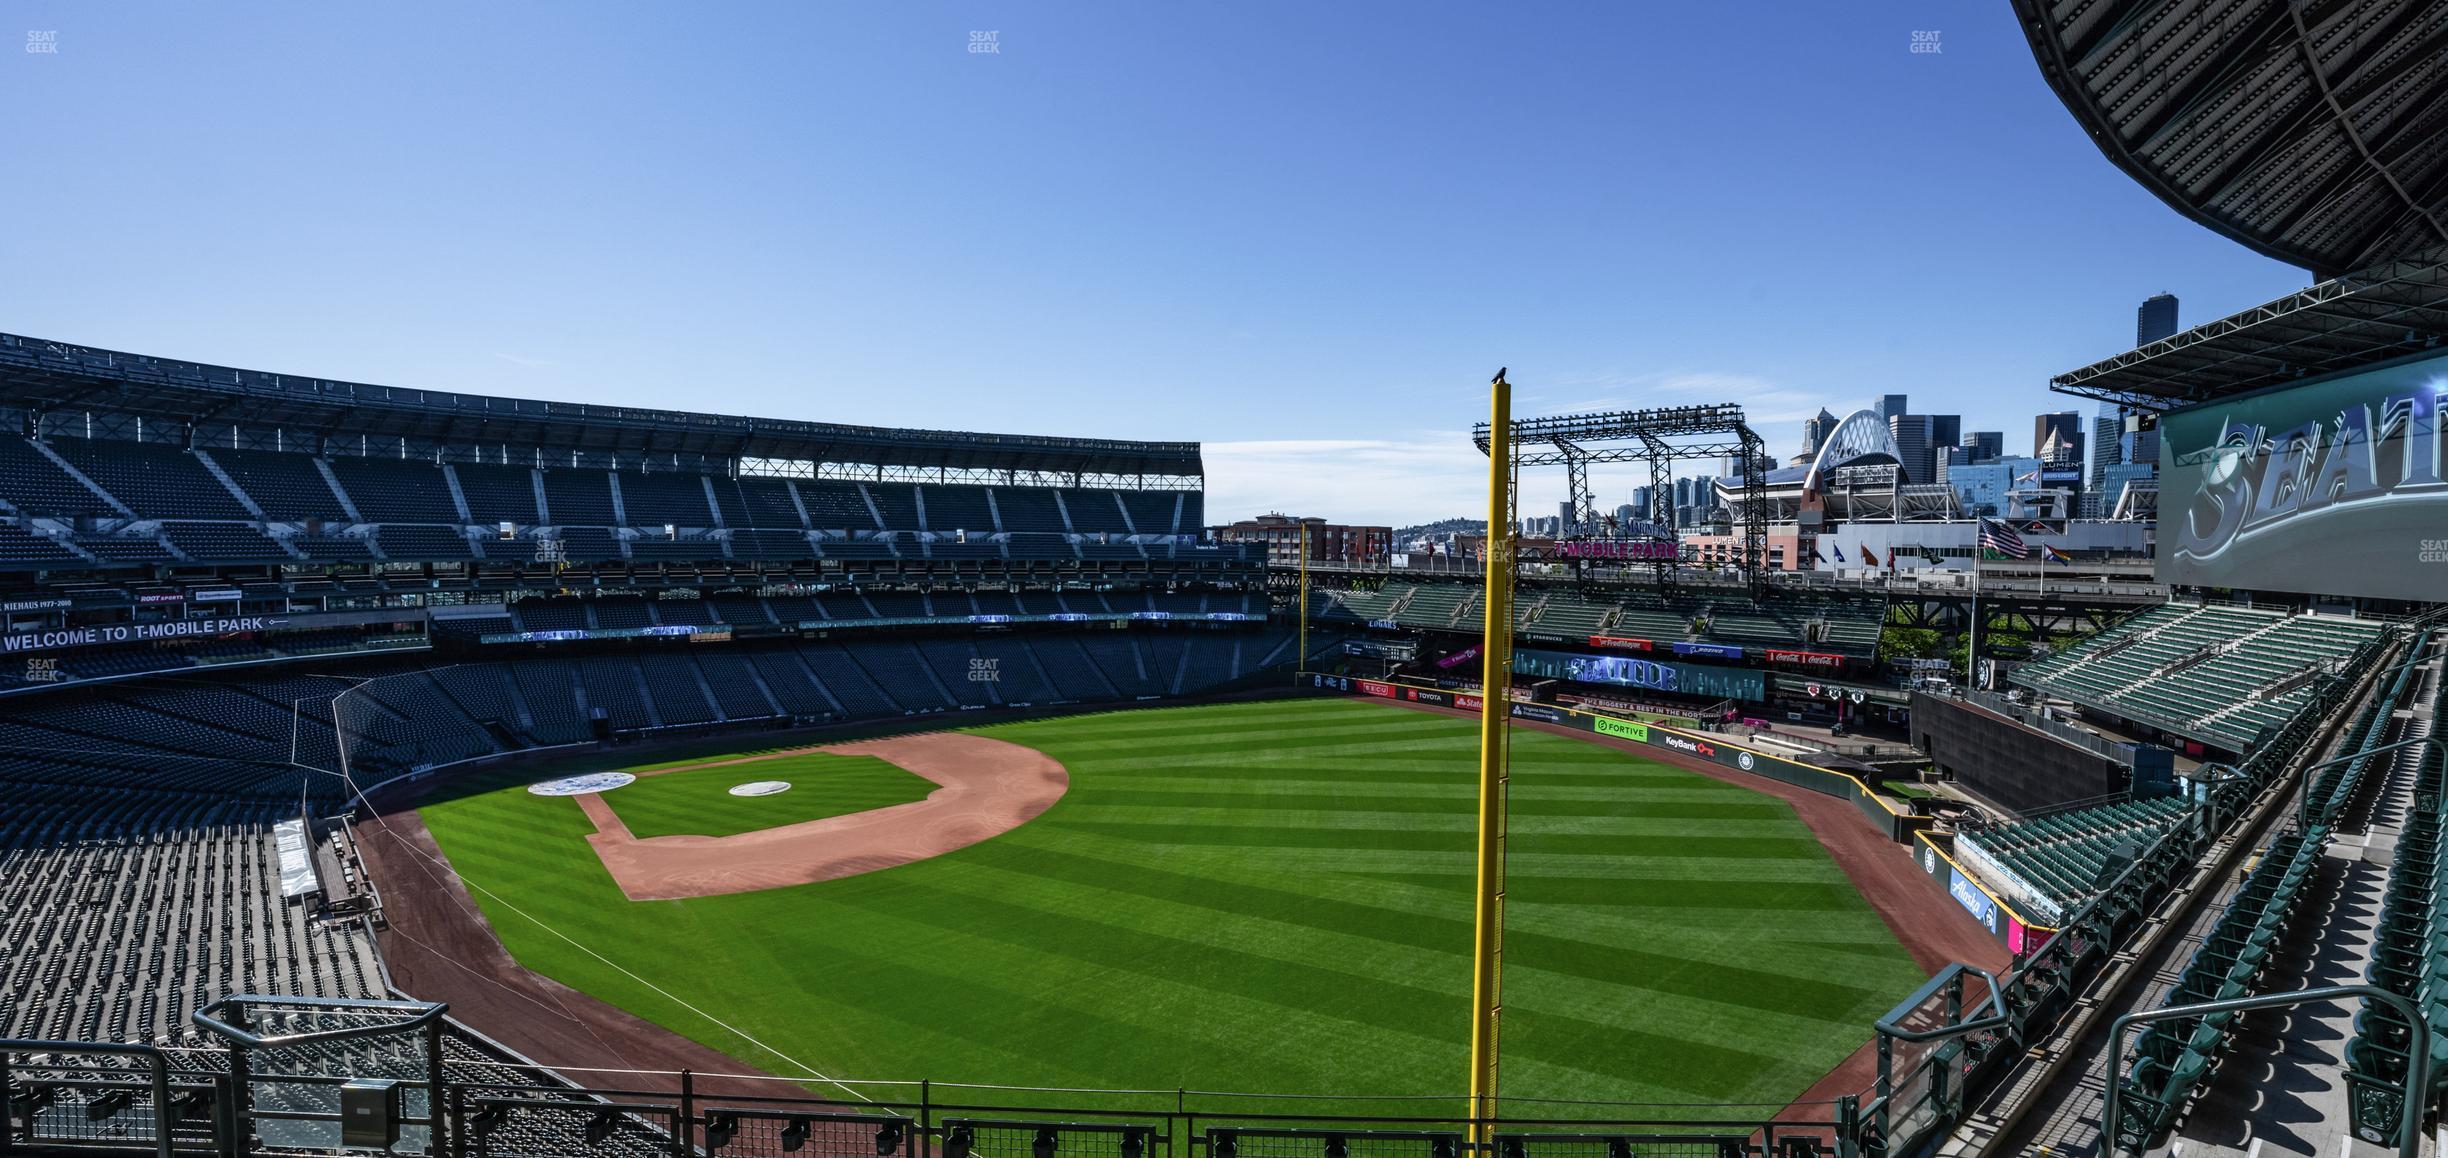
(2015, 0, 2448, 279)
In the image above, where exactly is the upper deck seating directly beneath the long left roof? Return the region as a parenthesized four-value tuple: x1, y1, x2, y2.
(0, 438, 1212, 577)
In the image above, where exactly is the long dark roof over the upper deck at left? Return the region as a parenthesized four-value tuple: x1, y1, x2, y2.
(0, 333, 1204, 477)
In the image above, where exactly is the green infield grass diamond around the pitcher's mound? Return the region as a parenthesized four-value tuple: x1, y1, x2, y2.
(605, 752, 935, 837)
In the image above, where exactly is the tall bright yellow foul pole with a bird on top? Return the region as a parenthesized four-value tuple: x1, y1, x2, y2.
(1471, 370, 1513, 1146)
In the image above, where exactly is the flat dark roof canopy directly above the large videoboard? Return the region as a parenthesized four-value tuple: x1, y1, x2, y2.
(2049, 245, 2448, 411)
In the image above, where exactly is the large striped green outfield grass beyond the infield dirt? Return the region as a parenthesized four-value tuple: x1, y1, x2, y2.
(424, 700, 1922, 1116)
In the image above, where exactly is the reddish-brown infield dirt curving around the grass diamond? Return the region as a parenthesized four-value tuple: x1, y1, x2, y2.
(575, 732, 1070, 901)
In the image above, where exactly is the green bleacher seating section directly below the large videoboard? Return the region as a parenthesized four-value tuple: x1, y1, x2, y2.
(2012, 602, 2382, 752)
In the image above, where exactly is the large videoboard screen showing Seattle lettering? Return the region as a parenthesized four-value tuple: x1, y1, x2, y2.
(2157, 353, 2448, 600)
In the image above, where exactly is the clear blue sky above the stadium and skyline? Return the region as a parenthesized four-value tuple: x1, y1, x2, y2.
(0, 0, 2308, 521)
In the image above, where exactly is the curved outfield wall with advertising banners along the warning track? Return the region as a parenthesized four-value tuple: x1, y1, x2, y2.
(1300, 671, 2056, 952)
